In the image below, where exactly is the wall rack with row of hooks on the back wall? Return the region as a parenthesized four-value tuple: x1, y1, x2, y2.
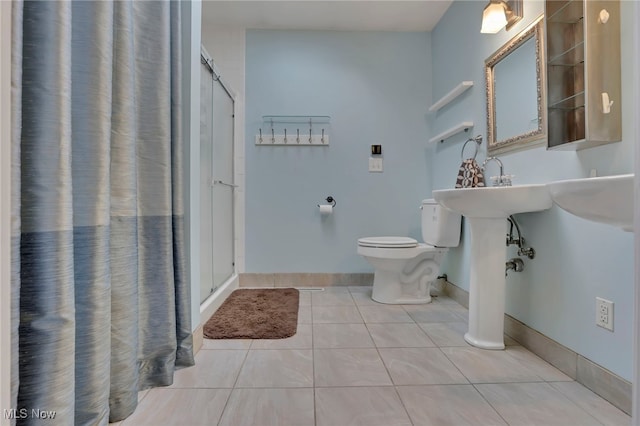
(256, 115, 331, 146)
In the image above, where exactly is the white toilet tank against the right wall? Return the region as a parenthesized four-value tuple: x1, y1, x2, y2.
(421, 198, 461, 247)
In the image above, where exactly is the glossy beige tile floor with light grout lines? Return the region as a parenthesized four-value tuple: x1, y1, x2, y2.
(114, 287, 630, 426)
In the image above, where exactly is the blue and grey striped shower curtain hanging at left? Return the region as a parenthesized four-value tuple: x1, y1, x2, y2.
(12, 1, 193, 425)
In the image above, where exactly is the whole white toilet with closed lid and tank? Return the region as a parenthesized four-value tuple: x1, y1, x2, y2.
(358, 199, 461, 304)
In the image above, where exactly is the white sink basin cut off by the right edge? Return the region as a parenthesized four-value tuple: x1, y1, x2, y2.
(548, 174, 634, 232)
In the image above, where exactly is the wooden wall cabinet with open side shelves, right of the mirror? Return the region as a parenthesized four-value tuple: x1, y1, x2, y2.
(545, 0, 622, 150)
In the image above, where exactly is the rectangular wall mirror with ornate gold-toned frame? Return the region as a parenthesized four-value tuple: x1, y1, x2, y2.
(485, 17, 546, 155)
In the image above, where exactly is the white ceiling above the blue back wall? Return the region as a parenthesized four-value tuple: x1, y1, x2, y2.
(202, 0, 453, 31)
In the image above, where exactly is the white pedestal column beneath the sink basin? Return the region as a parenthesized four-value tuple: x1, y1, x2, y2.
(464, 217, 507, 349)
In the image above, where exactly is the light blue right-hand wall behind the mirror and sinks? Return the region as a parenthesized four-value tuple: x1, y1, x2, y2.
(431, 0, 638, 380)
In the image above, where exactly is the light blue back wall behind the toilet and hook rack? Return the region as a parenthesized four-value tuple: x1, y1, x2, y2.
(245, 30, 431, 273)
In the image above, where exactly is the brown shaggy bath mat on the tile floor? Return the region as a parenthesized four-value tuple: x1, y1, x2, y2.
(204, 288, 300, 339)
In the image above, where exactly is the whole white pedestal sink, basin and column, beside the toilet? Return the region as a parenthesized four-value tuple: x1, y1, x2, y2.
(433, 184, 552, 349)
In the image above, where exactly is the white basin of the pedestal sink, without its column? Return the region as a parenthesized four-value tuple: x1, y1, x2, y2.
(433, 184, 553, 219)
